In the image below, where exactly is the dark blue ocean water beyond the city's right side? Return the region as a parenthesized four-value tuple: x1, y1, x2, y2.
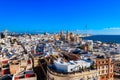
(83, 35, 120, 43)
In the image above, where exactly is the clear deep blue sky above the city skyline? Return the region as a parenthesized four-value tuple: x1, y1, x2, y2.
(0, 0, 120, 34)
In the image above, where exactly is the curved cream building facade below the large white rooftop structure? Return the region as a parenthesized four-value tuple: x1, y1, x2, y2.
(47, 69, 100, 80)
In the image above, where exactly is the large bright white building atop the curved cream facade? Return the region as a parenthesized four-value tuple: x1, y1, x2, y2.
(53, 58, 93, 72)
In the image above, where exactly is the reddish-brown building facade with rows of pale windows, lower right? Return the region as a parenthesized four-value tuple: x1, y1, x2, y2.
(96, 58, 114, 80)
